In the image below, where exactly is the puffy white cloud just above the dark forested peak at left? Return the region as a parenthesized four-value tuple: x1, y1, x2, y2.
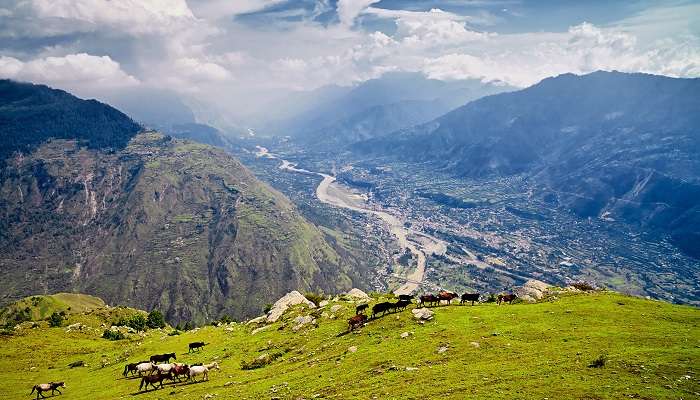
(0, 53, 139, 90)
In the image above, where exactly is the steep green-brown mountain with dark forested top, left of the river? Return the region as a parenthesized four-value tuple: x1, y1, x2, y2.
(0, 81, 361, 323)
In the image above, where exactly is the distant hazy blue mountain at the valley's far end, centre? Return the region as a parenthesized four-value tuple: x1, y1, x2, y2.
(254, 72, 510, 146)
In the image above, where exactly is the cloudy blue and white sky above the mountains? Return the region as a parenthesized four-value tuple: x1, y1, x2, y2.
(0, 0, 700, 122)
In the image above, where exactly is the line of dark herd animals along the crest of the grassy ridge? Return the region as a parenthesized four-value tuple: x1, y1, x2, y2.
(348, 291, 518, 331)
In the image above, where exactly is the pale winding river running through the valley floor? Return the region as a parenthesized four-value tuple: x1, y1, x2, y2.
(255, 146, 446, 294)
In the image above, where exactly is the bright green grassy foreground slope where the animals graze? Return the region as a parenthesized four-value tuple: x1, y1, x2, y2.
(0, 292, 700, 399)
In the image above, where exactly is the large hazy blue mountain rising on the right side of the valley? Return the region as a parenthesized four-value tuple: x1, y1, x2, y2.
(354, 71, 700, 257)
